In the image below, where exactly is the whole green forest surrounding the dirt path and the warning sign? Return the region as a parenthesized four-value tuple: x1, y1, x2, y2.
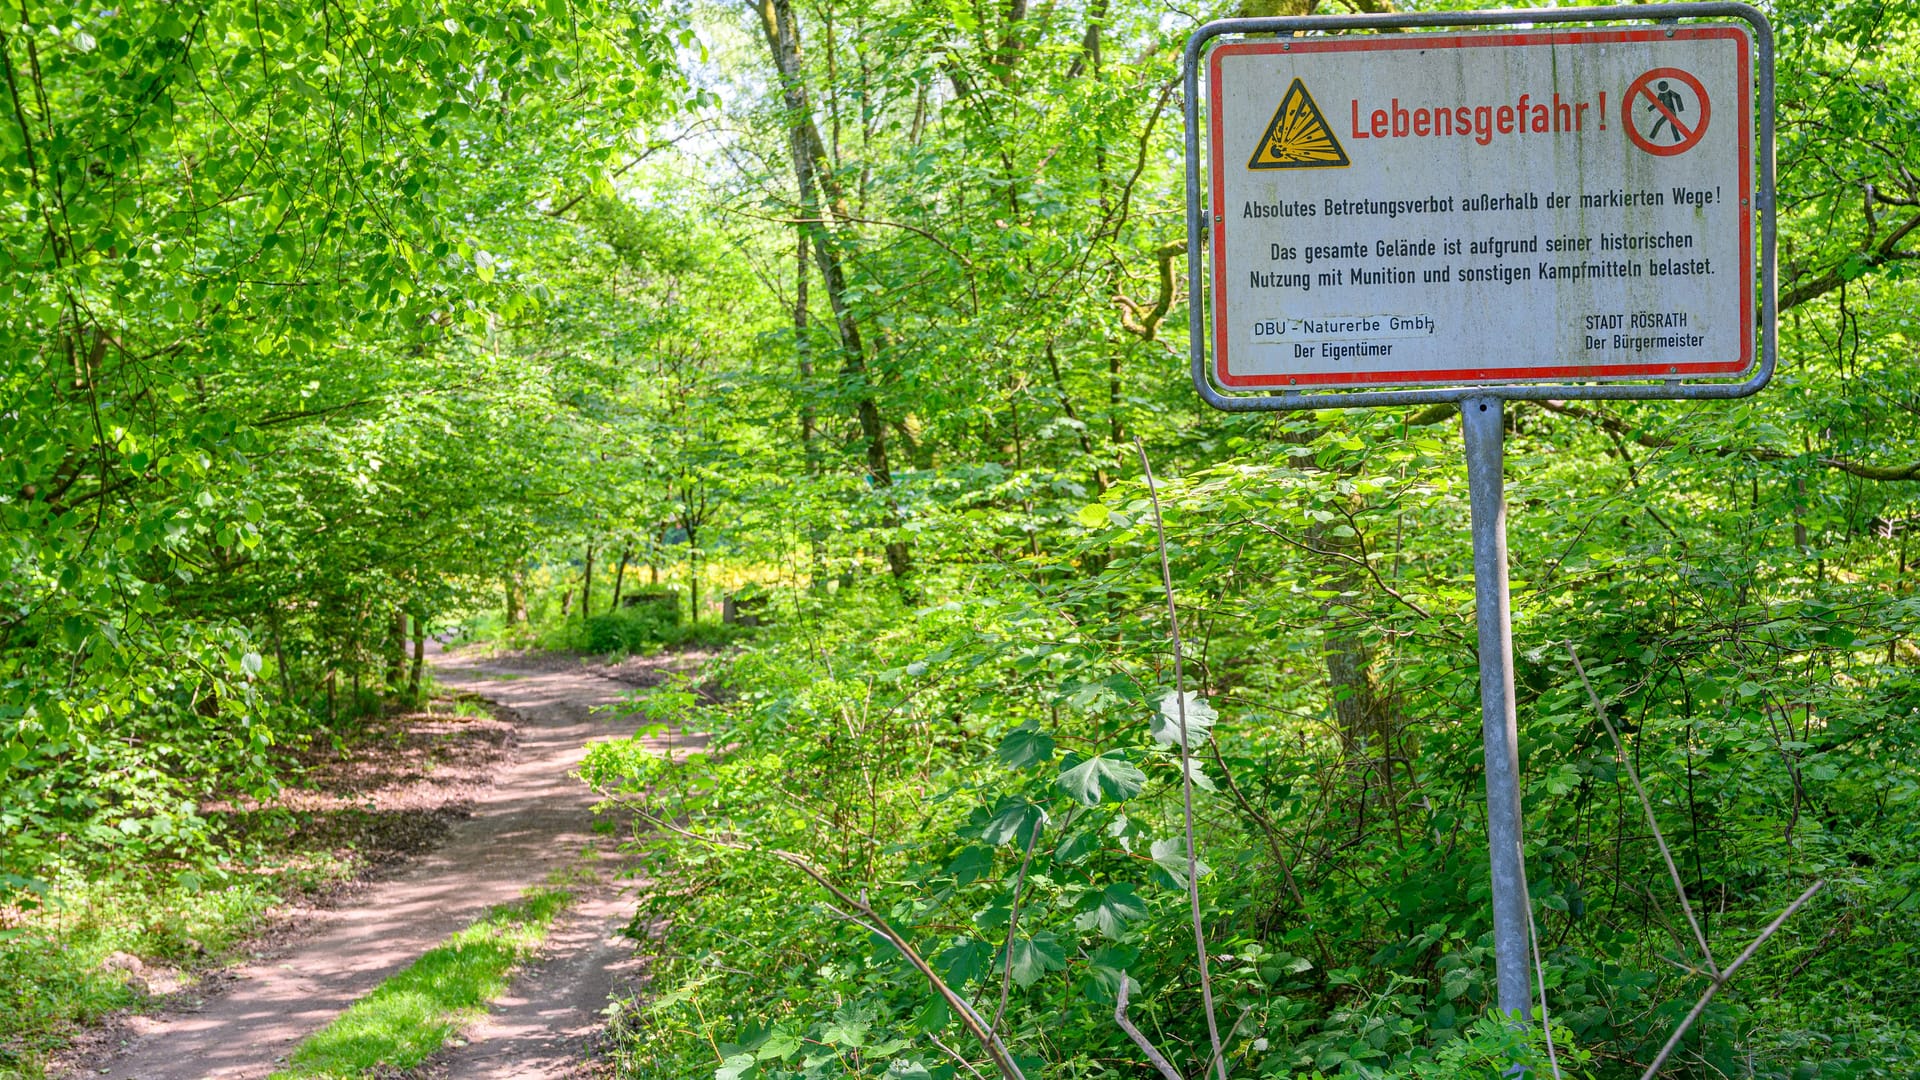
(0, 0, 1920, 1080)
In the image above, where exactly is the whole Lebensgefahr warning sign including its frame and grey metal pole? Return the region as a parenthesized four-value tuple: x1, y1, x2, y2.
(1185, 2, 1778, 1015)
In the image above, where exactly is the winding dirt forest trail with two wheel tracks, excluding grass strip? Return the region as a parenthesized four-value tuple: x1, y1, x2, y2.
(88, 655, 675, 1080)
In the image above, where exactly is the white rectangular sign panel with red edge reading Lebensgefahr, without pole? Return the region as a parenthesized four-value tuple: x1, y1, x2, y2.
(1206, 25, 1755, 390)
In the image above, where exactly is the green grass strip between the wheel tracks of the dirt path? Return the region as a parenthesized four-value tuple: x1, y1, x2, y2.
(269, 888, 574, 1080)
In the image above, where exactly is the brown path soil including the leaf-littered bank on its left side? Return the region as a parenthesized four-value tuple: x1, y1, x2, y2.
(69, 650, 707, 1080)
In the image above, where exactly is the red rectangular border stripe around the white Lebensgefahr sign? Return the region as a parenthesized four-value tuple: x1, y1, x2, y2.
(1208, 25, 1753, 390)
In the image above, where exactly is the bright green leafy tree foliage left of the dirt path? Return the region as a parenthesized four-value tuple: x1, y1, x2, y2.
(0, 0, 687, 892)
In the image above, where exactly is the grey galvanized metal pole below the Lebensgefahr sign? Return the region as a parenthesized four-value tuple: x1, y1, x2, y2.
(1459, 396, 1532, 1020)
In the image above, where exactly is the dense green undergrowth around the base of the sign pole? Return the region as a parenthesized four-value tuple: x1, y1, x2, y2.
(584, 457, 1920, 1080)
